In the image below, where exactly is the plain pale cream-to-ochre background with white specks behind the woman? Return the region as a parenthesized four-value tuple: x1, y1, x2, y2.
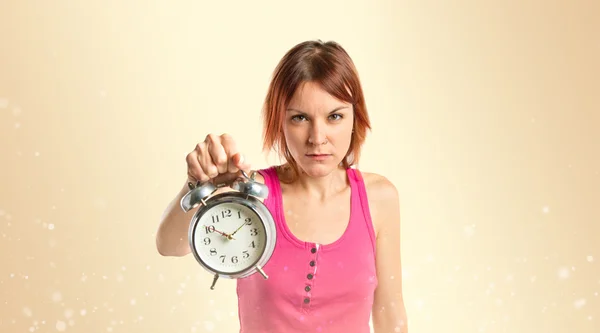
(0, 0, 600, 333)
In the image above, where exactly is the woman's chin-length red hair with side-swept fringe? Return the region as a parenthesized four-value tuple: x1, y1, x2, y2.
(262, 40, 371, 180)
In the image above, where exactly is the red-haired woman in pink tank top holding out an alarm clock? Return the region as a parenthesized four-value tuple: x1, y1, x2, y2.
(157, 41, 408, 333)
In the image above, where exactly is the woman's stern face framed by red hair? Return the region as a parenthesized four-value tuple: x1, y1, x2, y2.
(283, 82, 354, 177)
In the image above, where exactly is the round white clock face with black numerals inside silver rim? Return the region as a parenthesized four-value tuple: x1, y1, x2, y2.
(192, 202, 266, 274)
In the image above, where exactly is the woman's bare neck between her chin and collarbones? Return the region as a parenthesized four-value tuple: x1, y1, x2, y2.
(284, 163, 347, 201)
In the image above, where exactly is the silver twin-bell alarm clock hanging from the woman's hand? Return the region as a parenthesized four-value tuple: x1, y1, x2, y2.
(180, 171, 276, 289)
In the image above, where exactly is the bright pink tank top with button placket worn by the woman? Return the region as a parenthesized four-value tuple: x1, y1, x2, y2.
(237, 167, 377, 333)
